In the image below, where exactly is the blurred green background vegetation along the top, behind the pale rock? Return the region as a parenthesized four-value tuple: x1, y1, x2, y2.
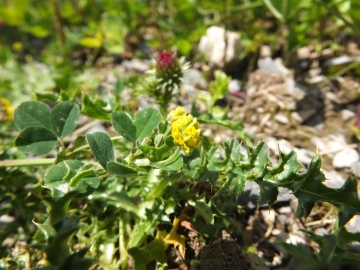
(0, 0, 360, 105)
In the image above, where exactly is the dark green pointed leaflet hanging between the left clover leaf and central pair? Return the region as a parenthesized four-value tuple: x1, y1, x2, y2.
(86, 132, 115, 170)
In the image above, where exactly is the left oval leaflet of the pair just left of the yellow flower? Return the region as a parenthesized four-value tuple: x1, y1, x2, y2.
(110, 112, 136, 142)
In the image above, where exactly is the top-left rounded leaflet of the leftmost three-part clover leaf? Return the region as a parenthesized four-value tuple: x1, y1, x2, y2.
(14, 101, 51, 131)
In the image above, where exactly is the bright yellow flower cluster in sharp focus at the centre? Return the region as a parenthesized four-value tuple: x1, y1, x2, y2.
(168, 107, 201, 154)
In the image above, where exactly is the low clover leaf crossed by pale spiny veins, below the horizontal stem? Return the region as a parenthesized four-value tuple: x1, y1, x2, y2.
(45, 160, 100, 198)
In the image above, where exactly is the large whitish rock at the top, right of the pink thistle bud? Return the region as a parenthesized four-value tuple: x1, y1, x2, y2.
(198, 26, 242, 67)
